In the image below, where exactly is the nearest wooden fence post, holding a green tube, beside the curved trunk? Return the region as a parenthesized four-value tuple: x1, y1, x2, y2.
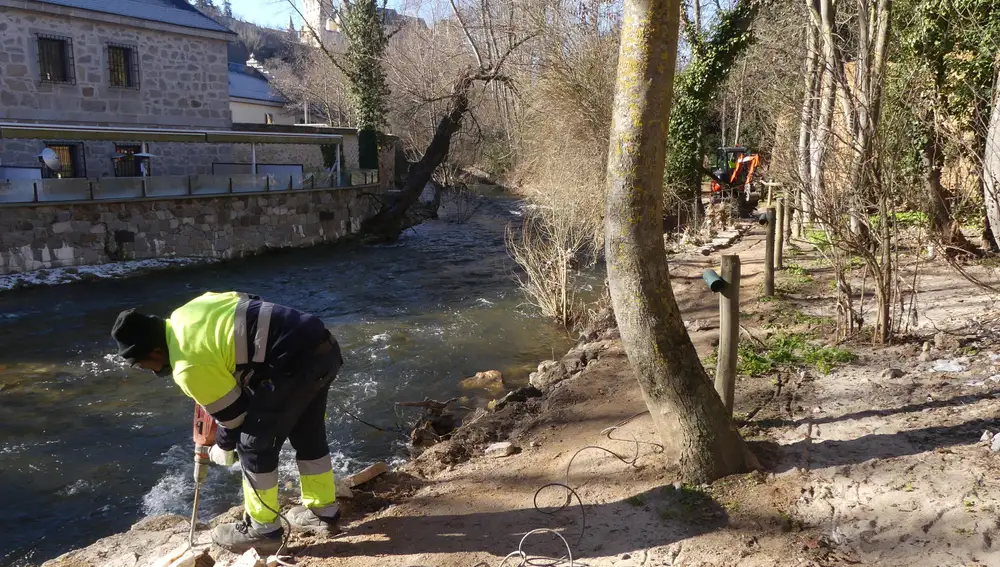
(715, 254, 740, 417)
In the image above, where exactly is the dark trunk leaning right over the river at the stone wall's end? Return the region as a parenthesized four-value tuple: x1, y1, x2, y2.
(361, 69, 477, 240)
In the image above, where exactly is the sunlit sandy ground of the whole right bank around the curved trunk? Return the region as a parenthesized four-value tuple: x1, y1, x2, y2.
(43, 223, 1000, 567)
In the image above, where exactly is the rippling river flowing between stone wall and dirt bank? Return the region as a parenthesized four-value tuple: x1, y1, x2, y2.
(0, 197, 569, 566)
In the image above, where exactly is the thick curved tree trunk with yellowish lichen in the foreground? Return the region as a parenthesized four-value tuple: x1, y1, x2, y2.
(606, 0, 758, 481)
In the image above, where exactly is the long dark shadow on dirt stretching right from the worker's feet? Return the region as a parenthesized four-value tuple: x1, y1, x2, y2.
(296, 486, 729, 558)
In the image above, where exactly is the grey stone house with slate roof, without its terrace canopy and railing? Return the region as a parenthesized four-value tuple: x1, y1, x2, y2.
(0, 0, 233, 177)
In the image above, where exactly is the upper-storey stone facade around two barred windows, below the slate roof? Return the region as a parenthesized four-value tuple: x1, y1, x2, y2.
(0, 2, 232, 128)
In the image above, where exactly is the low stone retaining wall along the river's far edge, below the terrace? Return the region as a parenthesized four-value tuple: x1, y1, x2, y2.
(0, 187, 374, 274)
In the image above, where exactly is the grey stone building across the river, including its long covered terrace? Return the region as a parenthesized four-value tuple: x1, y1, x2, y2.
(0, 0, 357, 180)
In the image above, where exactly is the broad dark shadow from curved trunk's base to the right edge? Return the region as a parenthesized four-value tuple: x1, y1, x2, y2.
(750, 419, 998, 473)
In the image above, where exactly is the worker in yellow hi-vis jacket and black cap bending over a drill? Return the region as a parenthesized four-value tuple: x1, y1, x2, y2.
(111, 292, 343, 552)
